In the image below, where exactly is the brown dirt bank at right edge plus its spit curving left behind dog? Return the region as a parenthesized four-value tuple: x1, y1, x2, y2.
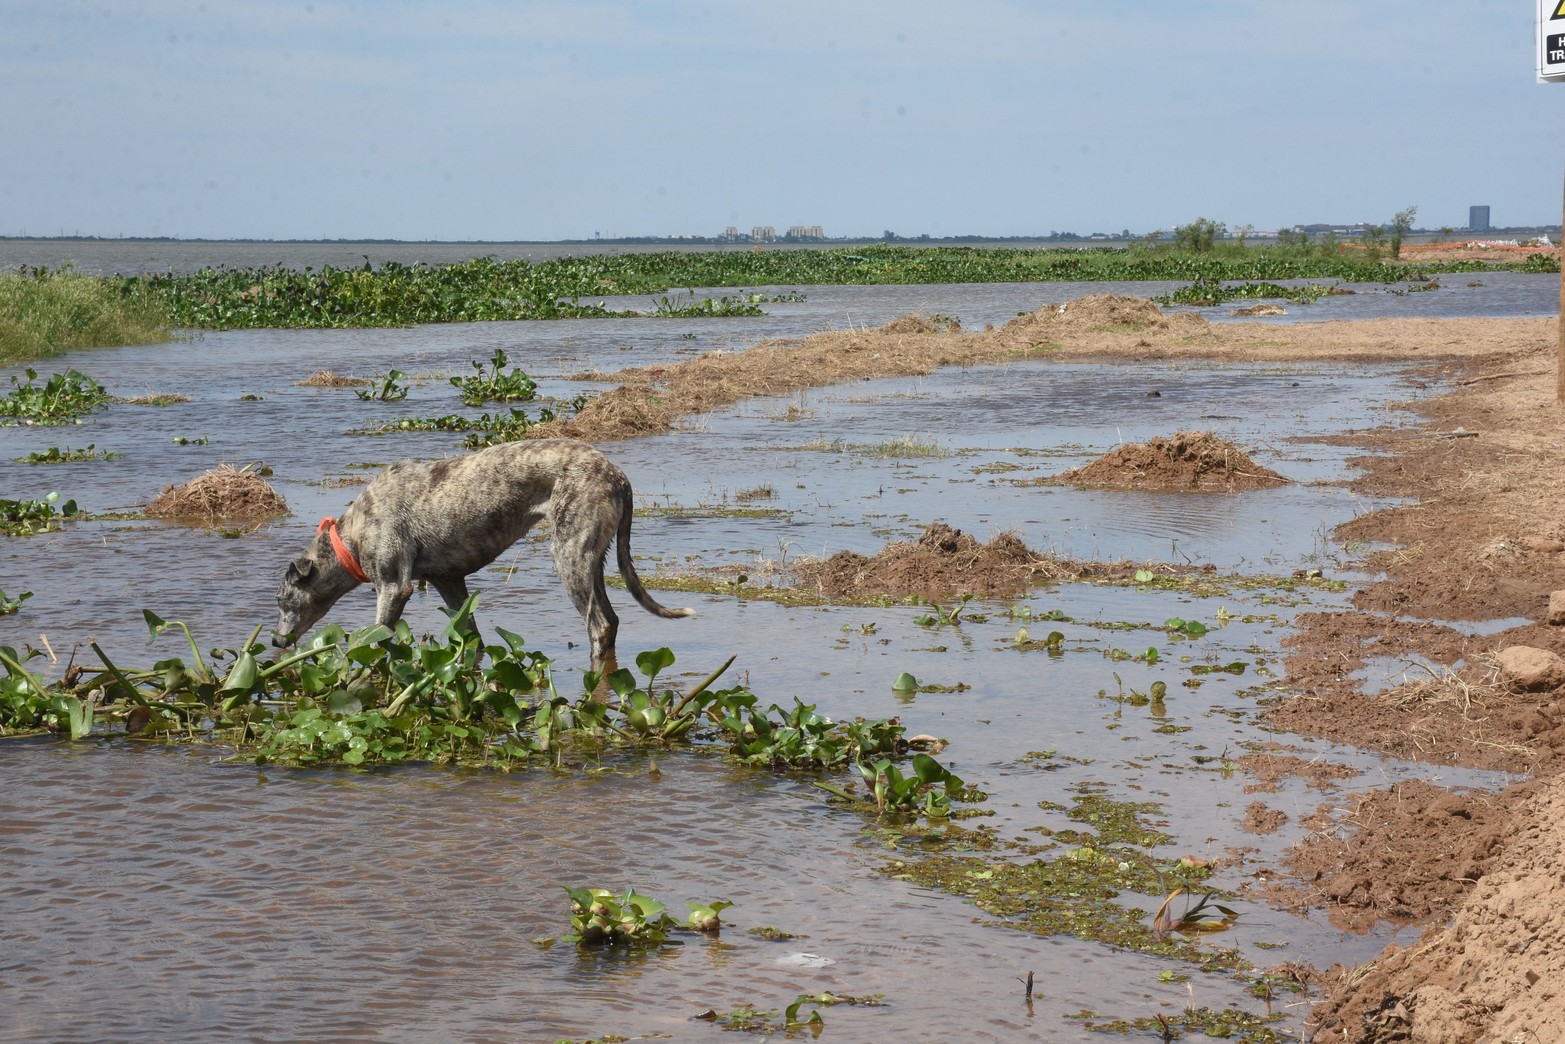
(550, 297, 1565, 1041)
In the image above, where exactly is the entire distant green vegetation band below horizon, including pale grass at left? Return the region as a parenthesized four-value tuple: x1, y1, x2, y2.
(0, 243, 1559, 363)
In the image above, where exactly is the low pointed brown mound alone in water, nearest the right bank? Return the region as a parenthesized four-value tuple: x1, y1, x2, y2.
(1052, 432, 1288, 493)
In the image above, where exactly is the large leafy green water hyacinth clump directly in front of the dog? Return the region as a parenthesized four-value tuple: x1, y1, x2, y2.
(0, 598, 970, 826)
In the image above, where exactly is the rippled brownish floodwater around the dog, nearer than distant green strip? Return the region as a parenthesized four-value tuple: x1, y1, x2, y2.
(0, 277, 1552, 1041)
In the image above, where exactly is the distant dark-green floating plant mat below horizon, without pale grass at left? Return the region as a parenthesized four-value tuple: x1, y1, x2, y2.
(121, 246, 1554, 329)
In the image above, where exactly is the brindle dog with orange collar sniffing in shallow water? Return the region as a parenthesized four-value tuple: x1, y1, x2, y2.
(272, 438, 693, 665)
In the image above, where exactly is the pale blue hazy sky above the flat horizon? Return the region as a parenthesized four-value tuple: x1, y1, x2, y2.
(0, 0, 1565, 241)
